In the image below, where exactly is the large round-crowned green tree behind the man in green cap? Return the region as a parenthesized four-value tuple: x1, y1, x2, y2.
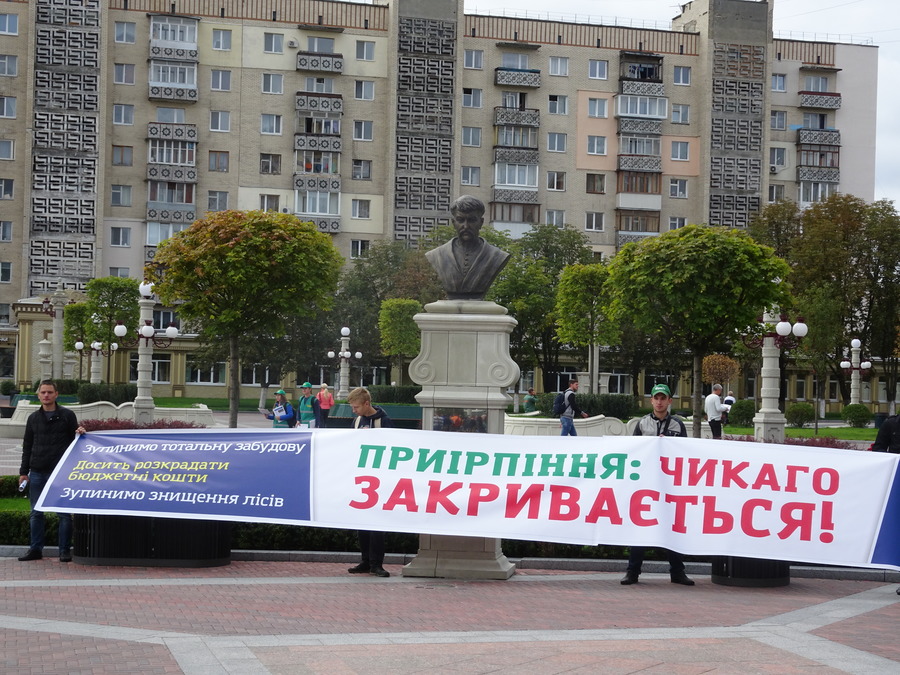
(609, 225, 789, 437)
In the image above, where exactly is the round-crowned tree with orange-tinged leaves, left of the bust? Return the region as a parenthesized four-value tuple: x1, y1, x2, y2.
(145, 211, 343, 427)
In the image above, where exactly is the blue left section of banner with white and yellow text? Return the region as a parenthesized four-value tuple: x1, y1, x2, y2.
(39, 429, 311, 522)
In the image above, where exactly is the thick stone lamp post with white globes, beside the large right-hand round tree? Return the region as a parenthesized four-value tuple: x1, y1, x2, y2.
(752, 312, 809, 443)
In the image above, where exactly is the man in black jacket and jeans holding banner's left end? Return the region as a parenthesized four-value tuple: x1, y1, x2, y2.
(19, 380, 84, 562)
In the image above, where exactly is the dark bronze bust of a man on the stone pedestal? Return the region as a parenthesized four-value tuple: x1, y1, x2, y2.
(425, 195, 509, 300)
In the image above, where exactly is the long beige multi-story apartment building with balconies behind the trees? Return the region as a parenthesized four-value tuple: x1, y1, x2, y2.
(0, 0, 877, 398)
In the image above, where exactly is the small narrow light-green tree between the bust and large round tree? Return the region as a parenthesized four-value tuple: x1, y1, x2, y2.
(554, 263, 618, 393)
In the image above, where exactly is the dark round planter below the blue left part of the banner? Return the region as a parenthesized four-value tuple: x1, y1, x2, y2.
(72, 514, 231, 567)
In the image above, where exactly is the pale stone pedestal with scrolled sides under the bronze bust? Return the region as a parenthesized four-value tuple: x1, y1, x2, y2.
(403, 300, 519, 579)
